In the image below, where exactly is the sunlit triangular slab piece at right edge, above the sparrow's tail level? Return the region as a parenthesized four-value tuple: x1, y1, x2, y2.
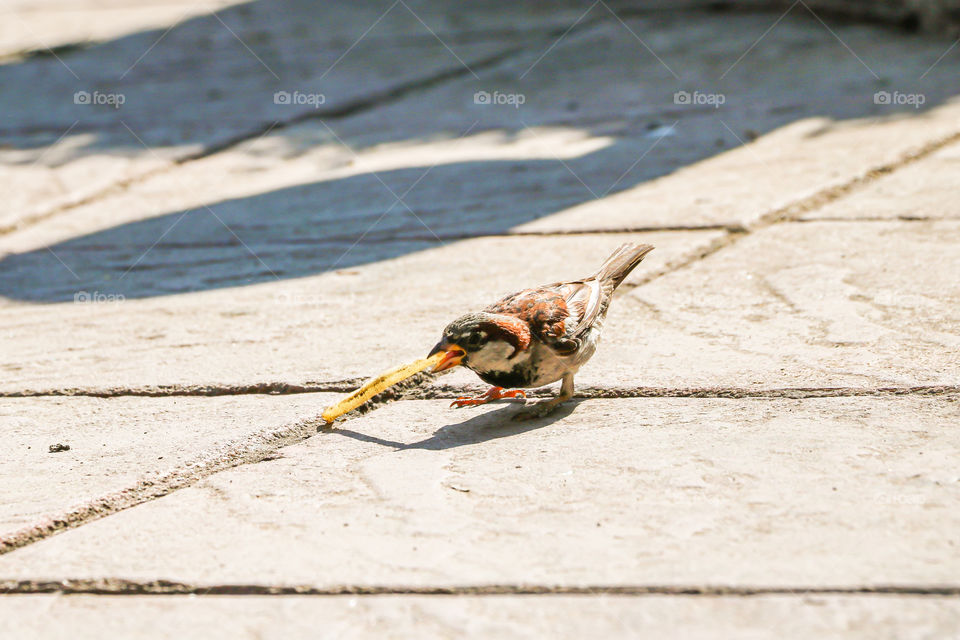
(800, 139, 960, 220)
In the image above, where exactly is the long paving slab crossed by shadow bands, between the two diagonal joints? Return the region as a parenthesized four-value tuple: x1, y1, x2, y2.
(0, 7, 956, 310)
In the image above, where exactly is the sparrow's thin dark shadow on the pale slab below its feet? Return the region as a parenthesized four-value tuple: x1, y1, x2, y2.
(325, 400, 581, 451)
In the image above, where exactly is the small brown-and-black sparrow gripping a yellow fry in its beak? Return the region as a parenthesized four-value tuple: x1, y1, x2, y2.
(429, 244, 653, 420)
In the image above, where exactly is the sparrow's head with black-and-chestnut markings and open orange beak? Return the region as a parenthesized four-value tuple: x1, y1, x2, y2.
(430, 312, 530, 372)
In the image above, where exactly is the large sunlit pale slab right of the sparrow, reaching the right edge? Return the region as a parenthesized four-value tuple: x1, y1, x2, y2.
(616, 221, 960, 388)
